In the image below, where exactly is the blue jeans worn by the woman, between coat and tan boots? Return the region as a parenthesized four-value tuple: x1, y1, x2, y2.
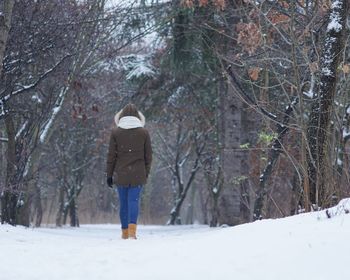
(117, 185, 142, 229)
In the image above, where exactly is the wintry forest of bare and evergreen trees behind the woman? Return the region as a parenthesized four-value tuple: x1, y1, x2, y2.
(0, 0, 350, 226)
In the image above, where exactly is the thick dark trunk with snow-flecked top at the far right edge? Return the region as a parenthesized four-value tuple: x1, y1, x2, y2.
(306, 0, 348, 209)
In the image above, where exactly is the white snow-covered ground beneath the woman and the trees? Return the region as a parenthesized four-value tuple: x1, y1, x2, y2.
(0, 201, 350, 280)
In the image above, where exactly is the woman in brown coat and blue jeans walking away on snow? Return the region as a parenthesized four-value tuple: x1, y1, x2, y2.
(107, 104, 152, 239)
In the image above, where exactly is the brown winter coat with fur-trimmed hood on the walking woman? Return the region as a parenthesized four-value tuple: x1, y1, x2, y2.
(107, 111, 152, 186)
